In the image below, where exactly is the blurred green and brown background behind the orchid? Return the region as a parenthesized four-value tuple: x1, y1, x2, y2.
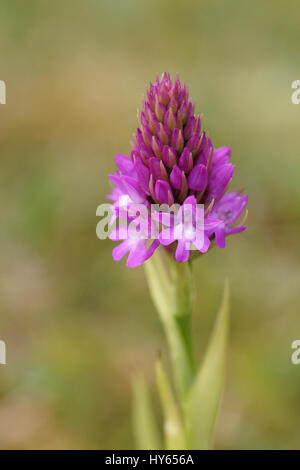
(0, 0, 300, 449)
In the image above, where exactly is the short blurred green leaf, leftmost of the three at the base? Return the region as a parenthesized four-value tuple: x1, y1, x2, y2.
(133, 376, 161, 450)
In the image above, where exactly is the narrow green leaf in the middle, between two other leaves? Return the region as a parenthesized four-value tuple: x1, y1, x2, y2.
(156, 359, 186, 450)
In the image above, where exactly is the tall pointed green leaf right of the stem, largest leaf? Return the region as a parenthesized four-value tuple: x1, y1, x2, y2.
(185, 282, 229, 449)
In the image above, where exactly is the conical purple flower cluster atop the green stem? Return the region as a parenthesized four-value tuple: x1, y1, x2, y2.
(109, 73, 247, 267)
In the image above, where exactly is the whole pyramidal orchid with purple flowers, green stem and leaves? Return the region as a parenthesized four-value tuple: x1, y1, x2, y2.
(108, 73, 247, 449)
